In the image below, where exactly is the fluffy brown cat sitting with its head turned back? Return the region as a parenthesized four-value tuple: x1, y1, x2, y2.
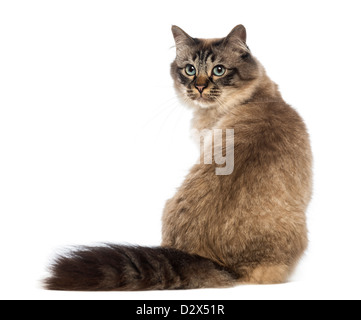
(45, 25, 312, 291)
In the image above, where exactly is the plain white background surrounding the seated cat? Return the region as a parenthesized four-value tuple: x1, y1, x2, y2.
(0, 0, 361, 299)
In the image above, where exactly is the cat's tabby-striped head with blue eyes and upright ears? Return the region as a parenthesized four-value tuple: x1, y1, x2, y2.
(171, 25, 258, 108)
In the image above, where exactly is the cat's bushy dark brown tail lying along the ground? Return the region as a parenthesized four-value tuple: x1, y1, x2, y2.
(45, 245, 238, 291)
